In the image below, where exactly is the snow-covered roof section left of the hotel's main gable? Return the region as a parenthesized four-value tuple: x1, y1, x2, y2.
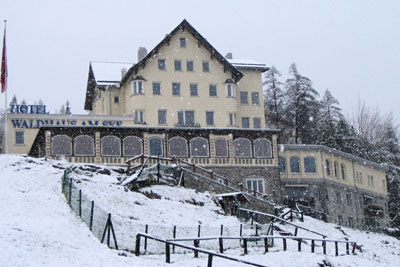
(90, 61, 134, 85)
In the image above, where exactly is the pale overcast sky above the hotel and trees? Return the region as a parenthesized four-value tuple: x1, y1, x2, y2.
(0, 0, 400, 122)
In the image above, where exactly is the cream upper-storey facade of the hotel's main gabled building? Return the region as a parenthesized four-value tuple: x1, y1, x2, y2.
(87, 21, 268, 131)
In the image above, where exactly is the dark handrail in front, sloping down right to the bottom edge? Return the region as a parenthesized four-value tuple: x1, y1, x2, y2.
(135, 233, 266, 267)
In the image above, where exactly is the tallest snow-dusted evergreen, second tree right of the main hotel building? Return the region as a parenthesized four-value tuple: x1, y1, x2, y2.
(285, 63, 319, 144)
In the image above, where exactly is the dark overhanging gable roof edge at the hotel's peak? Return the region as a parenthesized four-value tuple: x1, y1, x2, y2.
(122, 19, 243, 83)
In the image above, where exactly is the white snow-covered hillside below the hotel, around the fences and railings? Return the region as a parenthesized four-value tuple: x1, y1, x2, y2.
(0, 155, 400, 267)
